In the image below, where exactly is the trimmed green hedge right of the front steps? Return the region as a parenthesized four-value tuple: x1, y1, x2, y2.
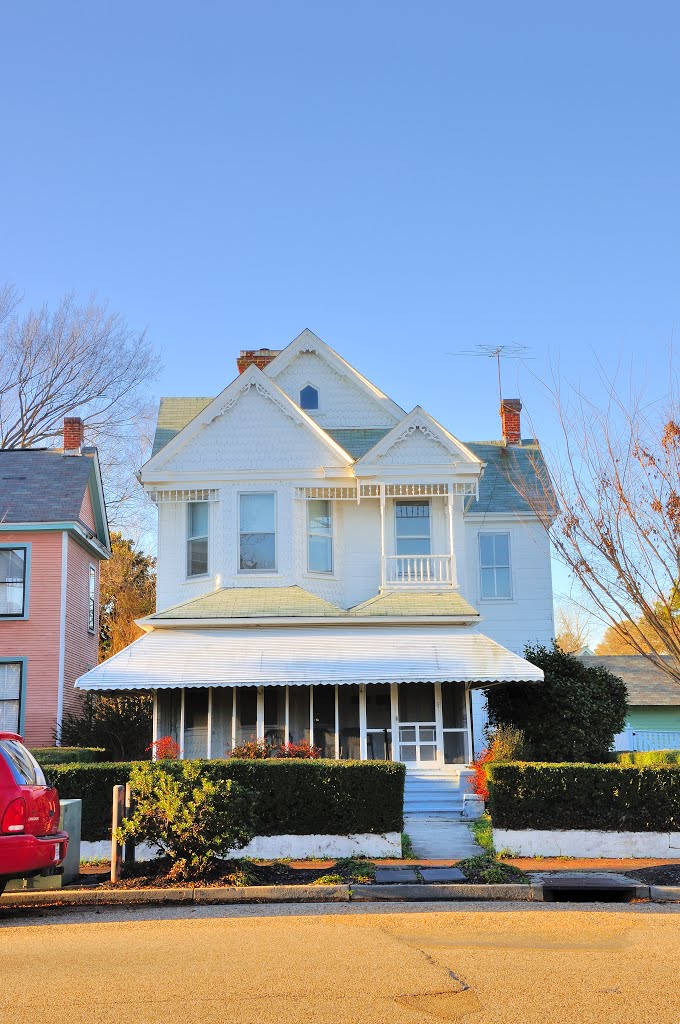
(486, 762, 680, 831)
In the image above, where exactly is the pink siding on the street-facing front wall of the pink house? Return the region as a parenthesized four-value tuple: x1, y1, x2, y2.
(0, 530, 61, 746)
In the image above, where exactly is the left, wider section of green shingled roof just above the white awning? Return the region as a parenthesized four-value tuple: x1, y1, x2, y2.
(150, 587, 345, 623)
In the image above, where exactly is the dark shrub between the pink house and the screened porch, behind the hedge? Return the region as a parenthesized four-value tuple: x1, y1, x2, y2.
(55, 693, 154, 761)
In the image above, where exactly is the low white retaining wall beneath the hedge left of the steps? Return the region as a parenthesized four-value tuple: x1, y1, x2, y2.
(80, 833, 401, 860)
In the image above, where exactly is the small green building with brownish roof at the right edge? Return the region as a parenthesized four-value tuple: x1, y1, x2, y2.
(580, 654, 680, 751)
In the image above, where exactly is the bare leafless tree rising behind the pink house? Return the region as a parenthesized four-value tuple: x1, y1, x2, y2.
(0, 287, 159, 530)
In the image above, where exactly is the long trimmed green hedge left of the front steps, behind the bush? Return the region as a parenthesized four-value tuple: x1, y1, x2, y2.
(49, 758, 406, 840)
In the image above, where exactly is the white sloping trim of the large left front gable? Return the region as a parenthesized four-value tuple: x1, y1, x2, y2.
(142, 364, 352, 473)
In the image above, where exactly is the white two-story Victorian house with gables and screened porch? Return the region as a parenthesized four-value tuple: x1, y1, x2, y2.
(76, 331, 553, 769)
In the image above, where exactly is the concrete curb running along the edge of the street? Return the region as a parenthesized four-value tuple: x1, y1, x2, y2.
(0, 883, 680, 911)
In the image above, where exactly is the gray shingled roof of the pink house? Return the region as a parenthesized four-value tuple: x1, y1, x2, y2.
(0, 449, 109, 548)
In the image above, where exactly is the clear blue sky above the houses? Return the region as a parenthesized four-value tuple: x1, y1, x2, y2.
(0, 0, 680, 618)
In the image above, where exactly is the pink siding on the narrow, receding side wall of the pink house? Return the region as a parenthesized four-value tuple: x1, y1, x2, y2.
(63, 538, 99, 712)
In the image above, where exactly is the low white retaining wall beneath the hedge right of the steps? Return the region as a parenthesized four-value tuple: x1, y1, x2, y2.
(494, 828, 680, 858)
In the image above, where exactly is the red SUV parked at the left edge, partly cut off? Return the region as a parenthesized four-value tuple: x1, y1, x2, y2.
(0, 732, 69, 893)
